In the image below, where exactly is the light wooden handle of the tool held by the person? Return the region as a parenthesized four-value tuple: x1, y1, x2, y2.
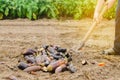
(78, 5, 108, 50)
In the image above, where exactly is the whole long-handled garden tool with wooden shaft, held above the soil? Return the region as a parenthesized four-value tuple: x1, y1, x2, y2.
(72, 5, 108, 52)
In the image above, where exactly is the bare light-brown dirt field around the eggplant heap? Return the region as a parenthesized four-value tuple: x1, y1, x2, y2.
(0, 19, 120, 80)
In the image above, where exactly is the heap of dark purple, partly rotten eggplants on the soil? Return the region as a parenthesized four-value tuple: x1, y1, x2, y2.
(18, 45, 76, 73)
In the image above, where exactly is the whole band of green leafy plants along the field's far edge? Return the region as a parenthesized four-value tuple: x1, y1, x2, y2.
(0, 0, 115, 20)
